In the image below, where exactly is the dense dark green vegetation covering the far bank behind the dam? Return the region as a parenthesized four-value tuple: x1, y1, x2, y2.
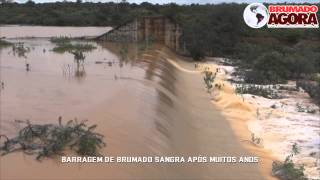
(0, 1, 320, 87)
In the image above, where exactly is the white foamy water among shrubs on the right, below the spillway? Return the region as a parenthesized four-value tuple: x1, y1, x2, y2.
(220, 62, 320, 179)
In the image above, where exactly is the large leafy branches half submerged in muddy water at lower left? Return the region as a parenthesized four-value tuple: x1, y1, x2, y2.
(0, 117, 106, 160)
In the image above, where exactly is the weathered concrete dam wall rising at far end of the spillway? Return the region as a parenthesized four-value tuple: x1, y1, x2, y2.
(98, 16, 186, 54)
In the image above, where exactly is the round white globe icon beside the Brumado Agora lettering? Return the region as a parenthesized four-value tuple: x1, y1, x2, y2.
(243, 3, 269, 28)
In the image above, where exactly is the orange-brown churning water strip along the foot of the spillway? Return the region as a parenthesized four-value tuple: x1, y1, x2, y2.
(186, 59, 277, 179)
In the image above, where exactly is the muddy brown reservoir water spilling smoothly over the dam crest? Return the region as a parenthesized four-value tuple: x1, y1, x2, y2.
(0, 26, 263, 180)
